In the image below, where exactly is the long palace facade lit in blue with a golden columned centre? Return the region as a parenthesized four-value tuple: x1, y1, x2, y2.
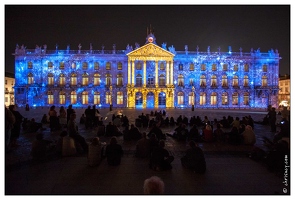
(13, 31, 281, 109)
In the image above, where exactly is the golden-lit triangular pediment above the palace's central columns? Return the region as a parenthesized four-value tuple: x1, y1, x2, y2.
(127, 43, 174, 58)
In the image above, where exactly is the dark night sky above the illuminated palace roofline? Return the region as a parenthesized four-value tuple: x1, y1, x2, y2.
(5, 5, 290, 75)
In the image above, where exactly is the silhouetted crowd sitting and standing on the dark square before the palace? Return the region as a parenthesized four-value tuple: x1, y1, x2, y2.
(5, 105, 290, 173)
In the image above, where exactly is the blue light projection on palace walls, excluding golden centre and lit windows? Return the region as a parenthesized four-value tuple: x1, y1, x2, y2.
(13, 41, 281, 108)
